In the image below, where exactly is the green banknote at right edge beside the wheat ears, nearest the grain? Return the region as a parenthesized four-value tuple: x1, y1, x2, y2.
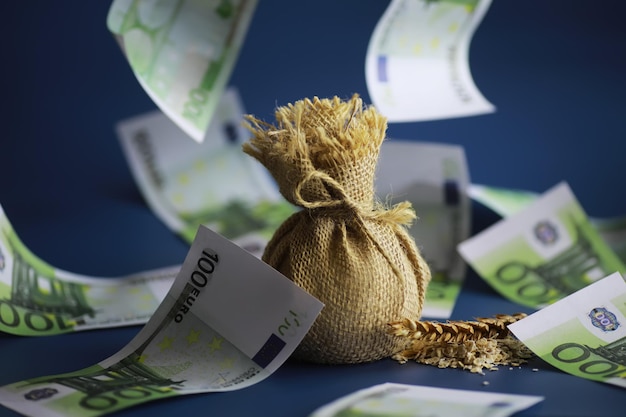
(509, 272, 626, 388)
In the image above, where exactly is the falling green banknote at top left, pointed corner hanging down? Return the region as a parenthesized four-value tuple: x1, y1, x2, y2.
(107, 0, 257, 142)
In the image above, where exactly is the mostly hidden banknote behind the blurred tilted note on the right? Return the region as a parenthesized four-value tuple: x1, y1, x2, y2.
(468, 184, 626, 263)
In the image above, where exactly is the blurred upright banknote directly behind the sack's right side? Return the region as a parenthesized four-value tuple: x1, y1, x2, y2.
(376, 140, 470, 318)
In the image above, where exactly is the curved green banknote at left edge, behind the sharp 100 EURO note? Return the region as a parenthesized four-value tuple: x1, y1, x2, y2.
(0, 206, 180, 336)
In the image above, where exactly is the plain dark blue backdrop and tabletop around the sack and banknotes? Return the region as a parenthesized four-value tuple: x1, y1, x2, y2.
(0, 0, 626, 417)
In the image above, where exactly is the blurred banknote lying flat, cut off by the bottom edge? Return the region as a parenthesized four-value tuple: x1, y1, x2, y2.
(310, 383, 543, 417)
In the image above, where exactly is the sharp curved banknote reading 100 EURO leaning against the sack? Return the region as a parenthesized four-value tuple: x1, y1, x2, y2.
(0, 227, 323, 417)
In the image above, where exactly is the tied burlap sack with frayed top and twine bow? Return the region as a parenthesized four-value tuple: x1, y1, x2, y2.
(243, 95, 430, 363)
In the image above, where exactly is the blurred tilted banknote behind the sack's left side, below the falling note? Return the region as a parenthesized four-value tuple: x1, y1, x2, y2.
(117, 89, 295, 256)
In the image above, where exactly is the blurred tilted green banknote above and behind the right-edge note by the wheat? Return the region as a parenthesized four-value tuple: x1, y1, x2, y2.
(458, 183, 626, 308)
